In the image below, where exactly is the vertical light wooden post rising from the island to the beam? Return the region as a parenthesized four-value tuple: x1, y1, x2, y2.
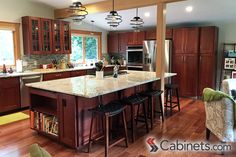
(156, 3, 166, 90)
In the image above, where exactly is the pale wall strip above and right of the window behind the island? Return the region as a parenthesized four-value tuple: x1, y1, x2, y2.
(71, 21, 108, 54)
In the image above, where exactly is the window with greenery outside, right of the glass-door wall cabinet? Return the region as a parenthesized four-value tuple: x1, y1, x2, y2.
(70, 30, 101, 63)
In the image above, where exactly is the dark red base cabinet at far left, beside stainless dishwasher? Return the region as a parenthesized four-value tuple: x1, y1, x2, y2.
(0, 77, 20, 112)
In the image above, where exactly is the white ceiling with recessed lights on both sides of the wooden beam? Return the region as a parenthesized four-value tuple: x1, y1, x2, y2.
(33, 0, 236, 30)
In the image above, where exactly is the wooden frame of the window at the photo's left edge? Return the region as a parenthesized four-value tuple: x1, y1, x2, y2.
(0, 21, 20, 68)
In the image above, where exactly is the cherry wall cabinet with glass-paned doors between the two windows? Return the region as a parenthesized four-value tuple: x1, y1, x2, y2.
(22, 16, 71, 54)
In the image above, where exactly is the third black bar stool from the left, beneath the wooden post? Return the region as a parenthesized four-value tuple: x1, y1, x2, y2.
(142, 90, 164, 129)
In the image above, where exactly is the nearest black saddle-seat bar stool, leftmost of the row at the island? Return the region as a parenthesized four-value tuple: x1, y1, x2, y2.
(88, 101, 128, 157)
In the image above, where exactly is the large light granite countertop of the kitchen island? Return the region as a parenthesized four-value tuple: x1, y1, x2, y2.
(26, 70, 176, 98)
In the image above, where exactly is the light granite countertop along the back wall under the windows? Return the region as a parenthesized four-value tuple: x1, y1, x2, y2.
(0, 65, 127, 78)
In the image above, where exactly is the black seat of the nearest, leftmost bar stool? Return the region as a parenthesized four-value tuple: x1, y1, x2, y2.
(89, 101, 126, 116)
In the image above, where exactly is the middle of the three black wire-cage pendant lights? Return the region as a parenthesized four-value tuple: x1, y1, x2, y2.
(105, 0, 122, 27)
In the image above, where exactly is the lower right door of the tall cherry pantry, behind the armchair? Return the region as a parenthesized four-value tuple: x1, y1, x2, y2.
(198, 54, 216, 96)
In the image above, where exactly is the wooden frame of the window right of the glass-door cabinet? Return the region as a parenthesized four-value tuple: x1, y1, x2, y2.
(68, 30, 102, 64)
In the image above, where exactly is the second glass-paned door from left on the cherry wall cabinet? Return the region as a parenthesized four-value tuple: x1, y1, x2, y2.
(41, 18, 52, 53)
